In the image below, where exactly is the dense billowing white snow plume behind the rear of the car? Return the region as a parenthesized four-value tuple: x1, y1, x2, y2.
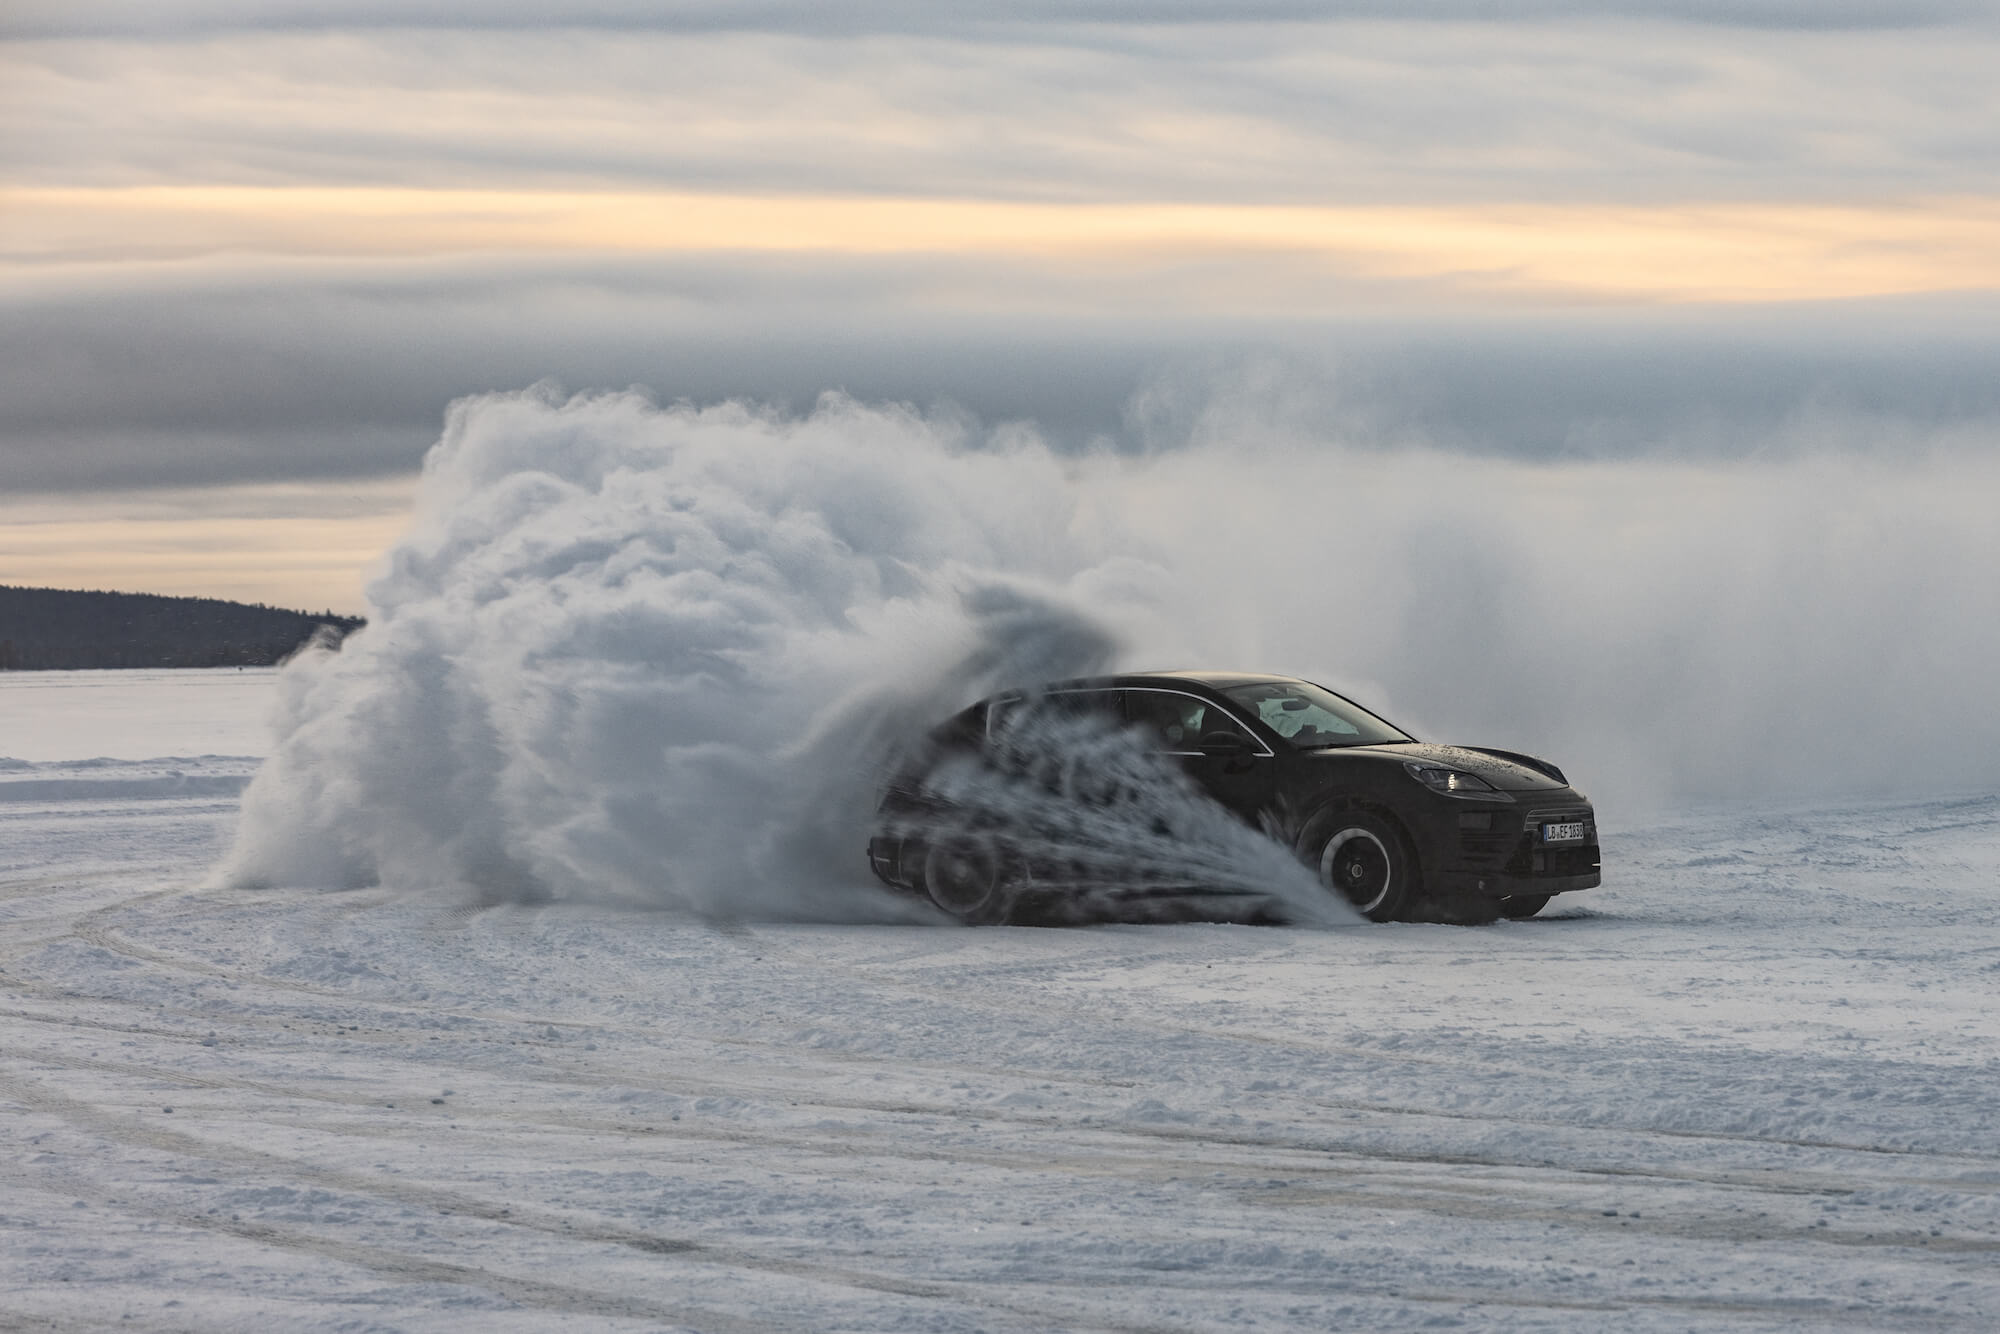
(224, 388, 1296, 920)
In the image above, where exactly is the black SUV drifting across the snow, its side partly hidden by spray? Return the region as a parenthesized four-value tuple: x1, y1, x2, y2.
(868, 672, 1600, 922)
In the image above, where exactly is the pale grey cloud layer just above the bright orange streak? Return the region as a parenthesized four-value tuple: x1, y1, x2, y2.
(0, 18, 2000, 204)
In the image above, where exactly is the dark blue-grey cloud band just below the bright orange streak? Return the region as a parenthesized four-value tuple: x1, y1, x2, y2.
(0, 258, 2000, 492)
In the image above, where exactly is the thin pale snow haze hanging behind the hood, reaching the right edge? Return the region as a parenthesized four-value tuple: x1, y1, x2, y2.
(1126, 444, 2000, 826)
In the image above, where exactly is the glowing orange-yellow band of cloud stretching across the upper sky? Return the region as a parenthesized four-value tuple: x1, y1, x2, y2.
(11, 186, 2000, 314)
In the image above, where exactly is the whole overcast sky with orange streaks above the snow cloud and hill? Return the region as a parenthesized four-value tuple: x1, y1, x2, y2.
(0, 0, 2000, 612)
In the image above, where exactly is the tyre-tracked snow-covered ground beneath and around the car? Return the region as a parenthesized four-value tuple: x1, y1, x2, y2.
(0, 676, 2000, 1332)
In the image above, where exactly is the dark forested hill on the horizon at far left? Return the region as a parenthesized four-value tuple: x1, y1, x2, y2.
(0, 584, 362, 672)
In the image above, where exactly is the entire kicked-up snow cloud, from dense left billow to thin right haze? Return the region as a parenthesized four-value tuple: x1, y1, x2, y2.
(224, 388, 2000, 918)
